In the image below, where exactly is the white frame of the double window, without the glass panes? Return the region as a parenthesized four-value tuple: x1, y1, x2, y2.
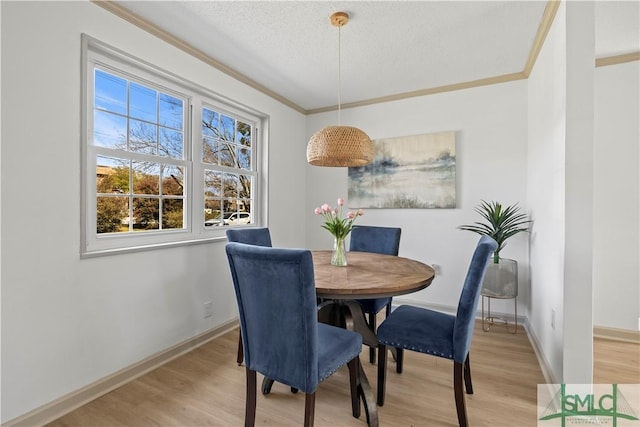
(80, 34, 268, 258)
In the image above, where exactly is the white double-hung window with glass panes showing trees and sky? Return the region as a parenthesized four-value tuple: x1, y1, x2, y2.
(82, 36, 266, 256)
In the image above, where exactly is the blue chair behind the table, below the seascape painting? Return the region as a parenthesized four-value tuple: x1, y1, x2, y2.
(349, 225, 402, 363)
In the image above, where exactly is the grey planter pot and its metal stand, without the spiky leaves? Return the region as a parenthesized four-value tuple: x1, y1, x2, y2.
(480, 258, 518, 334)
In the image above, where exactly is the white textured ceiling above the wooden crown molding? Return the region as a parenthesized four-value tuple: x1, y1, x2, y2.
(112, 0, 640, 110)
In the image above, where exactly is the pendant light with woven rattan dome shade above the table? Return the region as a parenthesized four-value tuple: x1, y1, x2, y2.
(307, 12, 374, 167)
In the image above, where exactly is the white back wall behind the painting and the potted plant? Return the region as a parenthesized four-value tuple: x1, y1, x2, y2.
(306, 80, 529, 315)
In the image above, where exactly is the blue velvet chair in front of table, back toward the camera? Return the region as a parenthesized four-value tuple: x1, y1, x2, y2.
(226, 242, 362, 426)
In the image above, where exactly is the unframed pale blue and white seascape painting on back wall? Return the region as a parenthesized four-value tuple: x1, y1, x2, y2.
(349, 131, 456, 209)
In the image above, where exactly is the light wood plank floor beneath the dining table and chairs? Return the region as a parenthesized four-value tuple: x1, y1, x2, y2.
(49, 326, 640, 427)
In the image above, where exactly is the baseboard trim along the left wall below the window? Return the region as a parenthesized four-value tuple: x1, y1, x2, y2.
(2, 319, 238, 427)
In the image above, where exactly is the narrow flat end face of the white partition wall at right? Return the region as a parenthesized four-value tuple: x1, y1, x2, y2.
(562, 2, 595, 384)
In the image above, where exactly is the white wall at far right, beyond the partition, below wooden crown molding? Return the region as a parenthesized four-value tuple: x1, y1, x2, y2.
(593, 61, 640, 330)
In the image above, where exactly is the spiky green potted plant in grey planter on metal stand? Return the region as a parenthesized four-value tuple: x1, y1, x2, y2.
(458, 200, 531, 333)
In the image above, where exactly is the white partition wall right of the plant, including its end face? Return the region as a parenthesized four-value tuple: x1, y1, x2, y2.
(528, 2, 608, 383)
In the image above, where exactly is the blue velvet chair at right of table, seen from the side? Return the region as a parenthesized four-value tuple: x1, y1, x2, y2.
(377, 236, 498, 427)
